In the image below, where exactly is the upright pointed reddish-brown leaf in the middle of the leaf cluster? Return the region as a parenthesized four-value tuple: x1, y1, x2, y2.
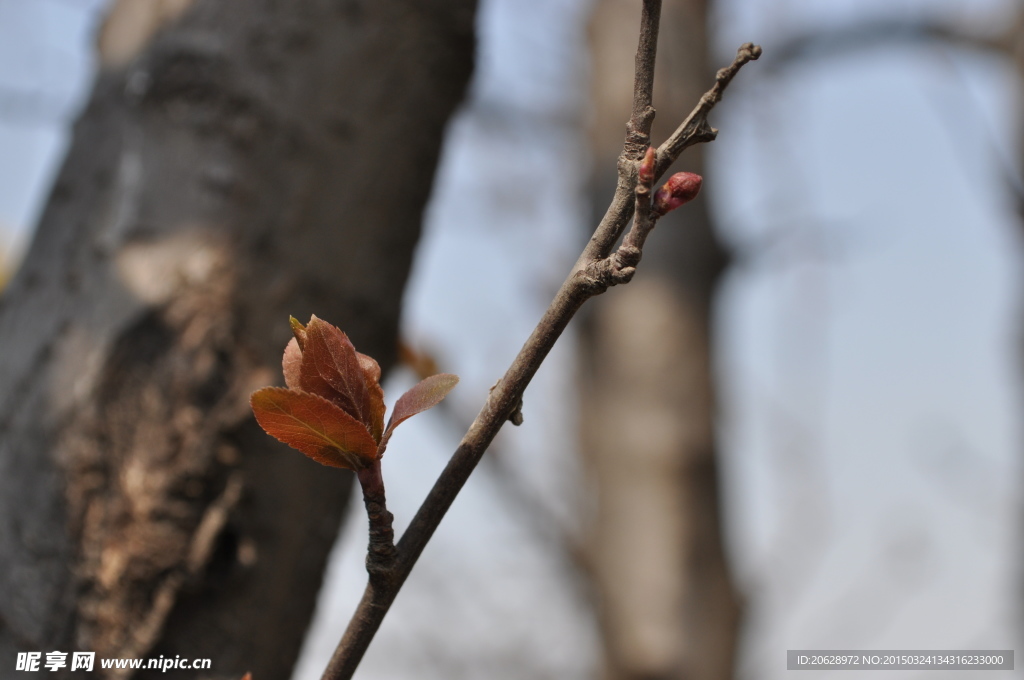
(299, 316, 371, 429)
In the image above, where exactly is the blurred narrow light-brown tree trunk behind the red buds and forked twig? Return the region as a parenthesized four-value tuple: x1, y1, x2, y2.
(581, 0, 739, 680)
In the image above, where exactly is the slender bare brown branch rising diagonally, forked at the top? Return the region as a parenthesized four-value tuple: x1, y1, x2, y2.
(323, 7, 761, 680)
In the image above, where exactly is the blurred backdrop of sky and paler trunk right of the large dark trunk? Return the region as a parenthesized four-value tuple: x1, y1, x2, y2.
(0, 0, 1024, 680)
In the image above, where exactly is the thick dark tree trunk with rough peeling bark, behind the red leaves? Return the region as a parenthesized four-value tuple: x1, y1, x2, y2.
(0, 0, 475, 680)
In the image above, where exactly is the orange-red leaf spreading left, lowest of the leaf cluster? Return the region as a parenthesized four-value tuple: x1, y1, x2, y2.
(250, 387, 377, 470)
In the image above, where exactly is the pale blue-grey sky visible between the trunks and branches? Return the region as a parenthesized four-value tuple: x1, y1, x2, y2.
(0, 0, 1024, 680)
